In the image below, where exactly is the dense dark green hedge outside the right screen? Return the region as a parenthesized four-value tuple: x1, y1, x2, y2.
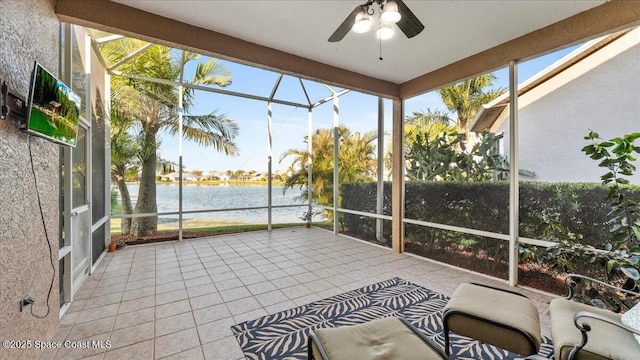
(341, 182, 640, 248)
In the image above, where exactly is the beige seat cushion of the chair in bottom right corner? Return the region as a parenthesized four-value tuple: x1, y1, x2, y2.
(549, 299, 640, 360)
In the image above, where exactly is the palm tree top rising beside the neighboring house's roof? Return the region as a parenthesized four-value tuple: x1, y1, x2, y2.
(438, 74, 505, 135)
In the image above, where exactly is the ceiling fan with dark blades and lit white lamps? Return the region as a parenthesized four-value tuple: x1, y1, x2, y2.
(329, 0, 424, 42)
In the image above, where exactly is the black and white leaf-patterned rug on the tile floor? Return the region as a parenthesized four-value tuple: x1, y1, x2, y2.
(231, 278, 553, 360)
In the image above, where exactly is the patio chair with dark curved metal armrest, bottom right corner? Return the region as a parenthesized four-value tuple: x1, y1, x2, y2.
(549, 274, 640, 360)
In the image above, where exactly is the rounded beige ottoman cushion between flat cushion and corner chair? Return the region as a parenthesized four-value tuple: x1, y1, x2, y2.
(444, 284, 541, 355)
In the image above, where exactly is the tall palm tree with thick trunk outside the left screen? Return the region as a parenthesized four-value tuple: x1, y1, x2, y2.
(103, 38, 238, 236)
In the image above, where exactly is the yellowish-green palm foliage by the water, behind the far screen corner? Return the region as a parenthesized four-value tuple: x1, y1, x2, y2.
(280, 126, 378, 210)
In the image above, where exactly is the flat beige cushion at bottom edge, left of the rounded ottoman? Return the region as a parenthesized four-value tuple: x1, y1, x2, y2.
(312, 317, 442, 360)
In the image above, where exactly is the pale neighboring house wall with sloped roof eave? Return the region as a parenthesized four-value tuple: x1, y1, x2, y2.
(491, 29, 640, 184)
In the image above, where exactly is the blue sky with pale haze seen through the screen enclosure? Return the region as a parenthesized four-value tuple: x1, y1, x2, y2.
(159, 46, 576, 174)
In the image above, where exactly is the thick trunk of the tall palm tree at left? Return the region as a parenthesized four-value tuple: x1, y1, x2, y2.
(131, 130, 158, 236)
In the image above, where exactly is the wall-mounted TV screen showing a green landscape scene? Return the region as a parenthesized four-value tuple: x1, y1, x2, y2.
(25, 62, 80, 147)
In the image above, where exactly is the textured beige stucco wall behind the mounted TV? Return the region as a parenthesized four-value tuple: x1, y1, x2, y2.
(0, 0, 60, 359)
